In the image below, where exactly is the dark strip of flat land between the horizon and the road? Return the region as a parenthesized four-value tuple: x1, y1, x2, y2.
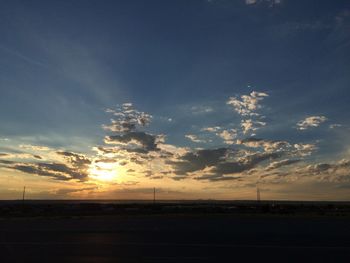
(0, 200, 350, 218)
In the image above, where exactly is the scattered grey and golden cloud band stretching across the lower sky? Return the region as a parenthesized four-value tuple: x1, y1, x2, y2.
(0, 91, 349, 199)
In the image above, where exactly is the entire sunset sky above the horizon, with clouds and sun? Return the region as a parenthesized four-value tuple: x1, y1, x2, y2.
(0, 0, 350, 201)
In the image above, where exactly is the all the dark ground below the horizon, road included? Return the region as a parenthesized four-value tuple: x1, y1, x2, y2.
(0, 202, 350, 262)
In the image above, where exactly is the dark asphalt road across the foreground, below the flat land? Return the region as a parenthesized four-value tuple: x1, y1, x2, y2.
(0, 215, 350, 263)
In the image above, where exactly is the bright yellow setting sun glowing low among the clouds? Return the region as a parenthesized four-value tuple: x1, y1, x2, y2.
(89, 162, 118, 182)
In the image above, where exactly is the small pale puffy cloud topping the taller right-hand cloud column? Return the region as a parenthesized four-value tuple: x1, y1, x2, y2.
(227, 91, 269, 116)
